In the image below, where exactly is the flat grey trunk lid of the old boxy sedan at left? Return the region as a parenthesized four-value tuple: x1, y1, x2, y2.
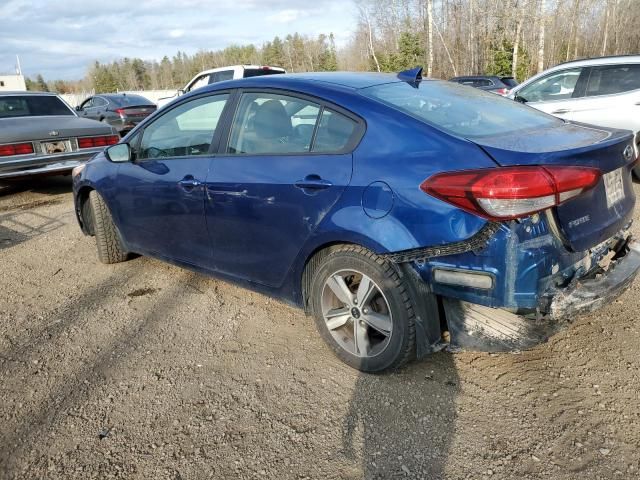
(0, 115, 113, 144)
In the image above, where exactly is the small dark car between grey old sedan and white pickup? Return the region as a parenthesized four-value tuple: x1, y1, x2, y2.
(76, 93, 156, 135)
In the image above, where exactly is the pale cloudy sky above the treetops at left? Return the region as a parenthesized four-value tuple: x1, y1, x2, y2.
(0, 0, 356, 80)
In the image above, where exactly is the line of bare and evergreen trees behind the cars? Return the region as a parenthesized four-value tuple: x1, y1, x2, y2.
(27, 0, 640, 93)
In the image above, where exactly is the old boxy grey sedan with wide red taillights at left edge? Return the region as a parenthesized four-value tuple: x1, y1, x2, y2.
(0, 92, 119, 180)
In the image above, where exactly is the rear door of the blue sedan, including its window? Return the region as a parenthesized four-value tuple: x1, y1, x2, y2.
(206, 91, 361, 286)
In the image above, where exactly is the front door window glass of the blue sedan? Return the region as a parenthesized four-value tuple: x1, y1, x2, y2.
(138, 94, 228, 159)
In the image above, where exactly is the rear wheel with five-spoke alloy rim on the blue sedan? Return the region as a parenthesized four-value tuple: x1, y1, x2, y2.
(310, 246, 415, 372)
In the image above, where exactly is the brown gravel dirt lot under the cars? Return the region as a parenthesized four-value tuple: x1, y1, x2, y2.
(0, 178, 640, 479)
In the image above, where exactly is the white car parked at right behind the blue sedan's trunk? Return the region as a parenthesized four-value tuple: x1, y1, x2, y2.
(508, 55, 640, 178)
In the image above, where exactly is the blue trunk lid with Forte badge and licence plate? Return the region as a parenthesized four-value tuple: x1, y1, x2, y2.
(471, 123, 635, 251)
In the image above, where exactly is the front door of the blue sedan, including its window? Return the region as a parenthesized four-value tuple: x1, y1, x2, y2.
(115, 93, 228, 268)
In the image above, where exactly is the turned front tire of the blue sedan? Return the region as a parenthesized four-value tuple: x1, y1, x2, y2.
(89, 190, 128, 264)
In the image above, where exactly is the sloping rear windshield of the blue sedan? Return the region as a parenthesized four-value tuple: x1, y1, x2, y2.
(361, 81, 562, 138)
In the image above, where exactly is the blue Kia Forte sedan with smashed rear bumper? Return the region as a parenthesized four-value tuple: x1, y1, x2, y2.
(74, 69, 640, 372)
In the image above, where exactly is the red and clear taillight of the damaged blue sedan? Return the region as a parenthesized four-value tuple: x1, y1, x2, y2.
(420, 166, 602, 220)
